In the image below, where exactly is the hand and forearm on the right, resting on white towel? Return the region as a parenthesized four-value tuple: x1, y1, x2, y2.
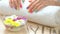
(28, 0, 60, 12)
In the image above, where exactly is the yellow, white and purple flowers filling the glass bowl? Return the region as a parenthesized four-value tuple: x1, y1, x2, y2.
(4, 15, 26, 27)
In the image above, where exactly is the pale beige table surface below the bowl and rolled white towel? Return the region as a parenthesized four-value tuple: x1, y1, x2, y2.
(0, 16, 57, 34)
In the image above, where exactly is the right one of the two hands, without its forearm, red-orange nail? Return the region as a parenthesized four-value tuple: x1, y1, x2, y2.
(27, 0, 48, 13)
